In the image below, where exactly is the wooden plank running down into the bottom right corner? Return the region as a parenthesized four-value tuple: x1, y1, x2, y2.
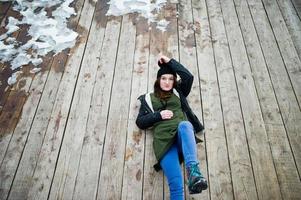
(235, 0, 301, 199)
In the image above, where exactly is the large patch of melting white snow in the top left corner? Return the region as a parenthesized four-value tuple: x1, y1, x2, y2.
(0, 0, 78, 83)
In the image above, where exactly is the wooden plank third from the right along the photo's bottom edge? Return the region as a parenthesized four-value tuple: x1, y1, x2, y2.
(207, 1, 257, 199)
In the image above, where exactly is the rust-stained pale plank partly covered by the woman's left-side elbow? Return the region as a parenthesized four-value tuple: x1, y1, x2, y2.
(122, 18, 149, 199)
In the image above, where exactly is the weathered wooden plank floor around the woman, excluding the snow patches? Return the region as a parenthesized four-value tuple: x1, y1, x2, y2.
(0, 0, 301, 200)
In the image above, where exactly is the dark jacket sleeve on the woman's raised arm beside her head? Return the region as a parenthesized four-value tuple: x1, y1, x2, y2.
(167, 58, 193, 97)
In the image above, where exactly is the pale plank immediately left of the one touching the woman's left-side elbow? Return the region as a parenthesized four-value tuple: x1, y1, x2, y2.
(97, 15, 136, 199)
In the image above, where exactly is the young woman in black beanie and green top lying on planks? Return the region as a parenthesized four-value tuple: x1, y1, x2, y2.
(136, 56, 208, 200)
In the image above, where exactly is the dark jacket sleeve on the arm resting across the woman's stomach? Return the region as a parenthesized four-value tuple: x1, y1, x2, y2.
(136, 99, 162, 129)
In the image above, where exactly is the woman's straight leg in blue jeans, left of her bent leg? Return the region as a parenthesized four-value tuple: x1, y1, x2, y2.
(160, 144, 184, 200)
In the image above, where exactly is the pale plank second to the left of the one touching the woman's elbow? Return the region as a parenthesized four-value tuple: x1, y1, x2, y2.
(74, 8, 121, 199)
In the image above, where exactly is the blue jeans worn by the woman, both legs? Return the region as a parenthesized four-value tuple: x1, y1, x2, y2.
(160, 121, 198, 200)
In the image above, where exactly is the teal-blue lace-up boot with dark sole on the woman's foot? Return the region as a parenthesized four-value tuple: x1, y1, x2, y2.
(186, 163, 208, 194)
